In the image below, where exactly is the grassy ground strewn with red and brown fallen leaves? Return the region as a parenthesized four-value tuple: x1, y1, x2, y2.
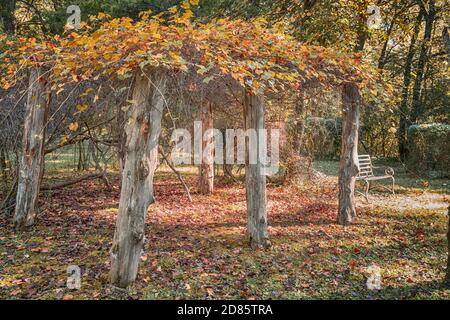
(0, 162, 450, 299)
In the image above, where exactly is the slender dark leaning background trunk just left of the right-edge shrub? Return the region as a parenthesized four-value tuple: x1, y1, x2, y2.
(397, 12, 423, 161)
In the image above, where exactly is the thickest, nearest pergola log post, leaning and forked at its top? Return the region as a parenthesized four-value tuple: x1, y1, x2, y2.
(111, 70, 166, 288)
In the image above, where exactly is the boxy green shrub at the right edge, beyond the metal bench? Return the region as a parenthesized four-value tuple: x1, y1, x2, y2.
(406, 123, 450, 177)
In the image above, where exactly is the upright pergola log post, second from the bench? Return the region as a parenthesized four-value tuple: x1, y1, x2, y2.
(244, 92, 270, 248)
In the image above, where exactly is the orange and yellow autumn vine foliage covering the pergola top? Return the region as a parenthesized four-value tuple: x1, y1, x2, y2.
(0, 0, 379, 94)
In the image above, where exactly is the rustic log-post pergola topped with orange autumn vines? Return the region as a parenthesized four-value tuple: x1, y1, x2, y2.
(0, 1, 376, 287)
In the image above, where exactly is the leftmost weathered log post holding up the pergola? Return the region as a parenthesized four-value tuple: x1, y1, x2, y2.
(13, 68, 49, 230)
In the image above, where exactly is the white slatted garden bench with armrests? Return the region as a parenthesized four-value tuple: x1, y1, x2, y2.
(356, 154, 395, 201)
